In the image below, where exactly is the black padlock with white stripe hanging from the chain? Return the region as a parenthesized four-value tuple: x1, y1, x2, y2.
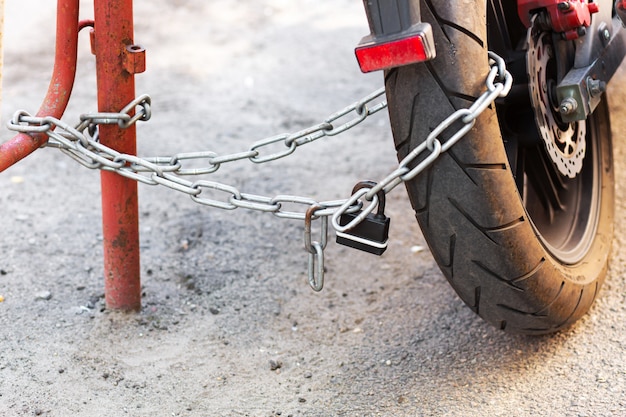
(337, 181, 391, 255)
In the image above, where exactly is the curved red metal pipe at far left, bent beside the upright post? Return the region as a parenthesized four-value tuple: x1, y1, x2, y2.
(0, 0, 78, 172)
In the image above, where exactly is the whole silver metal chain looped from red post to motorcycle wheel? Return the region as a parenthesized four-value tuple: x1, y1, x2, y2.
(8, 52, 512, 291)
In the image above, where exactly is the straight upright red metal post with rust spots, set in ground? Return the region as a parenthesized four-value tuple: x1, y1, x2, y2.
(94, 0, 141, 310)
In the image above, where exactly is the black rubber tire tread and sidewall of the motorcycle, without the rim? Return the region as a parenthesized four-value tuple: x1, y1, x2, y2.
(385, 0, 614, 334)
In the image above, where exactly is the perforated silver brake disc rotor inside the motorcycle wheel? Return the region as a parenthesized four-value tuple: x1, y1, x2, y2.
(526, 25, 587, 178)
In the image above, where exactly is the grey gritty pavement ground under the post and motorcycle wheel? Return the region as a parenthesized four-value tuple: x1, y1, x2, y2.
(0, 0, 626, 417)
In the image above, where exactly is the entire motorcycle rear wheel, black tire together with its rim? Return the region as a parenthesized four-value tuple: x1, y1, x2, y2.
(385, 0, 614, 334)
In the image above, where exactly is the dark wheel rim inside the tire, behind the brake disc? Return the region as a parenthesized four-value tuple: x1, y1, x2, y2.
(488, 2, 602, 264)
